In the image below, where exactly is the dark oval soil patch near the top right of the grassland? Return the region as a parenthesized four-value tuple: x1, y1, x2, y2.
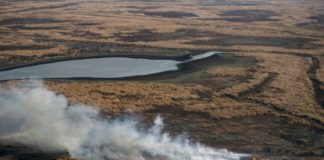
(219, 10, 279, 22)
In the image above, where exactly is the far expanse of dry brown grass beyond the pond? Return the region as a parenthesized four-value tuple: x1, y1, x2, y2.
(0, 0, 324, 58)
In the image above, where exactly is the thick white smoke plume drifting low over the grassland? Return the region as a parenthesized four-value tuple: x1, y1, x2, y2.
(0, 83, 246, 160)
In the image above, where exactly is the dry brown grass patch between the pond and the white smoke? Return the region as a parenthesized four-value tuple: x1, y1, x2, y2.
(46, 82, 204, 114)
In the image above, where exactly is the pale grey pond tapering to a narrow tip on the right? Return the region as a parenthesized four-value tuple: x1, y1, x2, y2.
(0, 52, 220, 80)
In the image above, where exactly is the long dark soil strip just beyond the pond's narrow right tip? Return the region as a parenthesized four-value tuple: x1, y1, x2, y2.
(190, 36, 321, 49)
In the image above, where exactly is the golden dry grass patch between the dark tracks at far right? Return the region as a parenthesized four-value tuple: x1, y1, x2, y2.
(235, 53, 324, 122)
